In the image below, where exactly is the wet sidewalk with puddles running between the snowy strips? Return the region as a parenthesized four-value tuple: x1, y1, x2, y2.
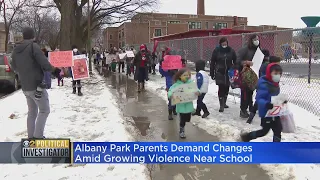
(96, 67, 270, 180)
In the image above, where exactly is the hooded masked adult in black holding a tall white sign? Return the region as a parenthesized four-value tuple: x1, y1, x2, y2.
(237, 34, 260, 118)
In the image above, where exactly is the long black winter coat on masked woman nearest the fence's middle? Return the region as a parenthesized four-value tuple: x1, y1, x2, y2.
(210, 47, 237, 85)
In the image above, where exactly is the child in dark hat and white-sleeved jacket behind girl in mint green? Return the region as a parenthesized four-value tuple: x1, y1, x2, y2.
(192, 60, 210, 118)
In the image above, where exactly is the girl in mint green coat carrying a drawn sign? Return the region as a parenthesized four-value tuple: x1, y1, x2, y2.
(168, 68, 200, 138)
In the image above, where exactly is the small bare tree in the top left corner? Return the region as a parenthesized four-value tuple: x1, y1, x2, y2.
(3, 0, 27, 51)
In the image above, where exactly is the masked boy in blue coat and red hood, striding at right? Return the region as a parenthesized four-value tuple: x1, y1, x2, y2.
(241, 63, 286, 142)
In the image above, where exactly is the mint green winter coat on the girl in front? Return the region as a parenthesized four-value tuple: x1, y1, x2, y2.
(168, 80, 198, 113)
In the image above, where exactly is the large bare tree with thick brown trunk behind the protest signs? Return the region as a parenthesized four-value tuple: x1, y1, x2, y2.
(30, 0, 159, 49)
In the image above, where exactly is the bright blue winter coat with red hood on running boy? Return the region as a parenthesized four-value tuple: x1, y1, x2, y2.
(256, 64, 280, 118)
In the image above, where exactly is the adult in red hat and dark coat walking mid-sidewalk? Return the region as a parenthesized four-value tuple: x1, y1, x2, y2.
(133, 44, 150, 92)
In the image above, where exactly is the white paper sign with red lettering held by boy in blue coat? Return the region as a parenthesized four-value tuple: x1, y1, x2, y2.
(266, 94, 290, 117)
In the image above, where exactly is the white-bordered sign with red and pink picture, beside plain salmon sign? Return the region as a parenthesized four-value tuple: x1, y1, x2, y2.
(71, 55, 90, 80)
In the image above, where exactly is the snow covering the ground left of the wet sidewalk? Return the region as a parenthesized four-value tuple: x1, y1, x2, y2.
(0, 71, 147, 180)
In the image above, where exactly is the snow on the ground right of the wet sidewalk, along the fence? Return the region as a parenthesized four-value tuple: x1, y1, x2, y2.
(146, 65, 320, 180)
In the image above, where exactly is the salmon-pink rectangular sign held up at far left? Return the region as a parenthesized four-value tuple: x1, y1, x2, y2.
(49, 51, 74, 68)
